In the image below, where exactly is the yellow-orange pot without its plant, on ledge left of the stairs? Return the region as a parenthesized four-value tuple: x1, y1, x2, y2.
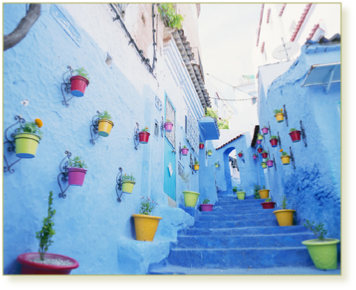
(132, 214, 162, 242)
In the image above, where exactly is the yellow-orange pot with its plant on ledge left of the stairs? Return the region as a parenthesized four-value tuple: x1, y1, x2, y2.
(132, 196, 162, 242)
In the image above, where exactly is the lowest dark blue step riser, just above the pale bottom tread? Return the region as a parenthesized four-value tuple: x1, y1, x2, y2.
(168, 248, 313, 268)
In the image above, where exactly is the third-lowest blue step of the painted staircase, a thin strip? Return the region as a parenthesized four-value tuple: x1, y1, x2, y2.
(178, 226, 310, 236)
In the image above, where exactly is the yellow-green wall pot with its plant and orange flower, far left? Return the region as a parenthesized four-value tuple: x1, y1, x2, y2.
(14, 119, 43, 158)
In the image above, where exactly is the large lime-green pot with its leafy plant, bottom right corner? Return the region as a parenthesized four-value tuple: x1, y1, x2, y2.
(302, 220, 340, 270)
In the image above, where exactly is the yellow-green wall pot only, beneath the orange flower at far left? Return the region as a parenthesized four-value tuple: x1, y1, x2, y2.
(15, 133, 41, 158)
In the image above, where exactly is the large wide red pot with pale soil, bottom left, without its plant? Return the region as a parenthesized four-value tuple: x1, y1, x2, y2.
(17, 252, 79, 275)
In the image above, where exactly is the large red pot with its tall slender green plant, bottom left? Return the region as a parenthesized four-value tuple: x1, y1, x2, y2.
(17, 191, 79, 275)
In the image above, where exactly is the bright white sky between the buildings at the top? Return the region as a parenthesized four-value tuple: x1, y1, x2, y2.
(199, 3, 261, 85)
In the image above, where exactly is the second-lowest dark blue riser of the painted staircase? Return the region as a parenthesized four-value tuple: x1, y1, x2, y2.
(171, 233, 315, 249)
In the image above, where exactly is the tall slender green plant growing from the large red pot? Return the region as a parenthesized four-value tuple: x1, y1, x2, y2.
(36, 191, 56, 261)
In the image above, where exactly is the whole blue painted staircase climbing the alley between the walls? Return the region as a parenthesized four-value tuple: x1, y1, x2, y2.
(148, 195, 340, 274)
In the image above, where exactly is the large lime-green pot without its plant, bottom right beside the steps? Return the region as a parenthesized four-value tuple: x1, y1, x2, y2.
(302, 239, 340, 270)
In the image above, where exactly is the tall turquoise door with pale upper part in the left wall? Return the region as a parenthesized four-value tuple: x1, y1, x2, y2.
(164, 95, 176, 200)
